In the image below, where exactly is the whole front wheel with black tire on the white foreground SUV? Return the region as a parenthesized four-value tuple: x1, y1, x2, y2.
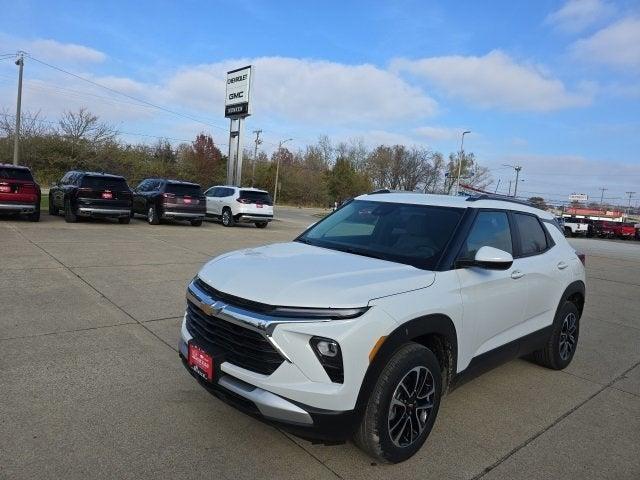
(354, 343, 442, 463)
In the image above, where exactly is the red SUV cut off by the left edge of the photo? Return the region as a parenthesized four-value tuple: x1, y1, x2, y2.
(0, 163, 40, 222)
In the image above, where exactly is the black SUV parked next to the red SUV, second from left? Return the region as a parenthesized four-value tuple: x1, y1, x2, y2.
(49, 170, 132, 223)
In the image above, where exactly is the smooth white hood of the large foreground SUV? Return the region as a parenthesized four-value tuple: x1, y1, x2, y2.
(198, 242, 435, 308)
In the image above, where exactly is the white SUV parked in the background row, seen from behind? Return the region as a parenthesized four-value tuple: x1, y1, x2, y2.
(204, 185, 273, 228)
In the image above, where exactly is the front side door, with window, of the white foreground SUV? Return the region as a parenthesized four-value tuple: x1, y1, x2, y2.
(456, 210, 527, 357)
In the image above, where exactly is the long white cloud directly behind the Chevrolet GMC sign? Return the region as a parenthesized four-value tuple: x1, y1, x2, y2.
(163, 57, 436, 125)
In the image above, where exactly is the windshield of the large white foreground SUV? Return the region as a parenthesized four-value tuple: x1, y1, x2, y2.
(296, 200, 464, 270)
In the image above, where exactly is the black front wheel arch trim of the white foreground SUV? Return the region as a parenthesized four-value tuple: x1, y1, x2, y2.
(356, 314, 458, 412)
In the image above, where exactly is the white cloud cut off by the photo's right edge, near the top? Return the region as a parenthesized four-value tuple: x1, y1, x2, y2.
(571, 17, 640, 70)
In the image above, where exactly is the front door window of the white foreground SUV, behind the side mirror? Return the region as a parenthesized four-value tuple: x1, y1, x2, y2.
(461, 212, 513, 259)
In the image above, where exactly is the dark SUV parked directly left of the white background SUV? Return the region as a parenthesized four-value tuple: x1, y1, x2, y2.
(131, 178, 207, 227)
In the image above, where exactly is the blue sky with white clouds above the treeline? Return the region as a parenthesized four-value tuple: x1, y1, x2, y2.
(0, 0, 640, 201)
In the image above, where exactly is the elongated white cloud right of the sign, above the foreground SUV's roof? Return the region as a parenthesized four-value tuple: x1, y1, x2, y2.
(392, 50, 591, 112)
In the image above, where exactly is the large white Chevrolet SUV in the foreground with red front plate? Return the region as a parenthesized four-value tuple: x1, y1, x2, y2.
(179, 193, 585, 462)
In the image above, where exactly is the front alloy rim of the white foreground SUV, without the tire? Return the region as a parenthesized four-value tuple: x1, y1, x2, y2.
(387, 366, 436, 447)
